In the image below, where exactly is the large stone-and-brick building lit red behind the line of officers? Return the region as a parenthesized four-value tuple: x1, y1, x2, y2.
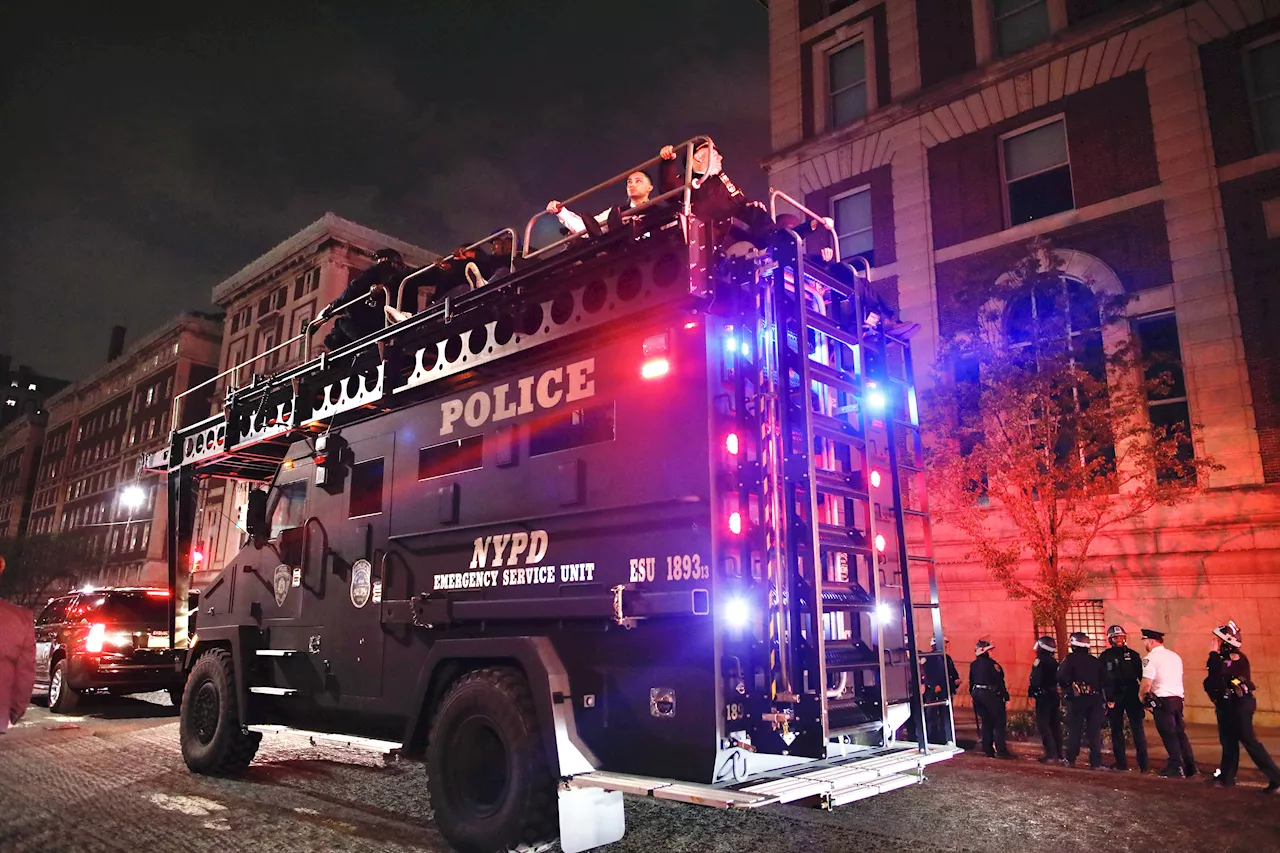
(767, 0, 1280, 725)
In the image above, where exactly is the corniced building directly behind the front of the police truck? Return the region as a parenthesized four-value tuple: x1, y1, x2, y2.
(195, 213, 439, 585)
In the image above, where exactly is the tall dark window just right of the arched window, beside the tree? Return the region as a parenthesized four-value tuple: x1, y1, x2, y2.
(1134, 311, 1196, 483)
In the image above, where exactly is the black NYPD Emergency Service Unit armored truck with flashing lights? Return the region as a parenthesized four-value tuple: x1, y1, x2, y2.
(145, 141, 957, 853)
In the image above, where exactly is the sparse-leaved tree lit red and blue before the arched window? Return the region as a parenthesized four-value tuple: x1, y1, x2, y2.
(927, 241, 1221, 648)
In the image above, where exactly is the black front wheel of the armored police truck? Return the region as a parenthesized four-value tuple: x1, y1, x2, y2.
(178, 648, 262, 776)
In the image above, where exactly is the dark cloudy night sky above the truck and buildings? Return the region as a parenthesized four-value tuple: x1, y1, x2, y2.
(0, 0, 768, 379)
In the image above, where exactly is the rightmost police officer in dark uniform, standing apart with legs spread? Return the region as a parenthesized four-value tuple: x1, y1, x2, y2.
(1204, 622, 1280, 794)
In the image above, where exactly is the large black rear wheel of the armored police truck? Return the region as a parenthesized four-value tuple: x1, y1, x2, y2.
(426, 667, 559, 853)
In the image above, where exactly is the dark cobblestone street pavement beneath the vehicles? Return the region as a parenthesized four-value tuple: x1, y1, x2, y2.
(0, 694, 1280, 853)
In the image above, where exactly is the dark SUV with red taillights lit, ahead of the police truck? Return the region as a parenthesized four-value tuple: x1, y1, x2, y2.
(36, 588, 183, 713)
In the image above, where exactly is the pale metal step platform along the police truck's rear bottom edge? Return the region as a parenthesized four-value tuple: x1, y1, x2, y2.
(567, 745, 961, 808)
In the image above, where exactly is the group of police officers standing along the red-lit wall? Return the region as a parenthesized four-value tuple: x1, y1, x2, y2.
(922, 622, 1280, 794)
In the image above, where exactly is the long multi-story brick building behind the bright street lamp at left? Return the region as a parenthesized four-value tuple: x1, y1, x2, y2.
(27, 314, 221, 584)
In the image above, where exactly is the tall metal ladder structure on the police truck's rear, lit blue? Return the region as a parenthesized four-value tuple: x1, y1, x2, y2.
(756, 193, 954, 758)
